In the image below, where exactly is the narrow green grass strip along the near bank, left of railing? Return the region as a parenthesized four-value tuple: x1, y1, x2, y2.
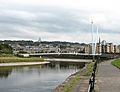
(64, 63, 94, 92)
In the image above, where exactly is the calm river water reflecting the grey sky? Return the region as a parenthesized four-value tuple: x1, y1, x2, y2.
(0, 62, 84, 92)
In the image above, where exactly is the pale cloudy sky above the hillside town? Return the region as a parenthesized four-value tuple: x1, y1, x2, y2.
(0, 0, 120, 44)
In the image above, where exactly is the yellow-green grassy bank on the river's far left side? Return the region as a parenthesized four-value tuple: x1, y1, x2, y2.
(0, 54, 43, 63)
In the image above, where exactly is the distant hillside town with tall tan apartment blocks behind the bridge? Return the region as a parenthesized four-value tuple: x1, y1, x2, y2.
(0, 38, 120, 54)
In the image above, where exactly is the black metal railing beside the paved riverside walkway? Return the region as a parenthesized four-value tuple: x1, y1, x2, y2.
(87, 61, 97, 92)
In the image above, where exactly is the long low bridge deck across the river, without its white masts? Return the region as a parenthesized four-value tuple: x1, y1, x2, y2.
(19, 53, 120, 59)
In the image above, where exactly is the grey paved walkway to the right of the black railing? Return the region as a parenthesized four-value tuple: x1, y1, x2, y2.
(98, 60, 120, 92)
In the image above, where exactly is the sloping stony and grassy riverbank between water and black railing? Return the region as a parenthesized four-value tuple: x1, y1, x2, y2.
(53, 63, 94, 92)
